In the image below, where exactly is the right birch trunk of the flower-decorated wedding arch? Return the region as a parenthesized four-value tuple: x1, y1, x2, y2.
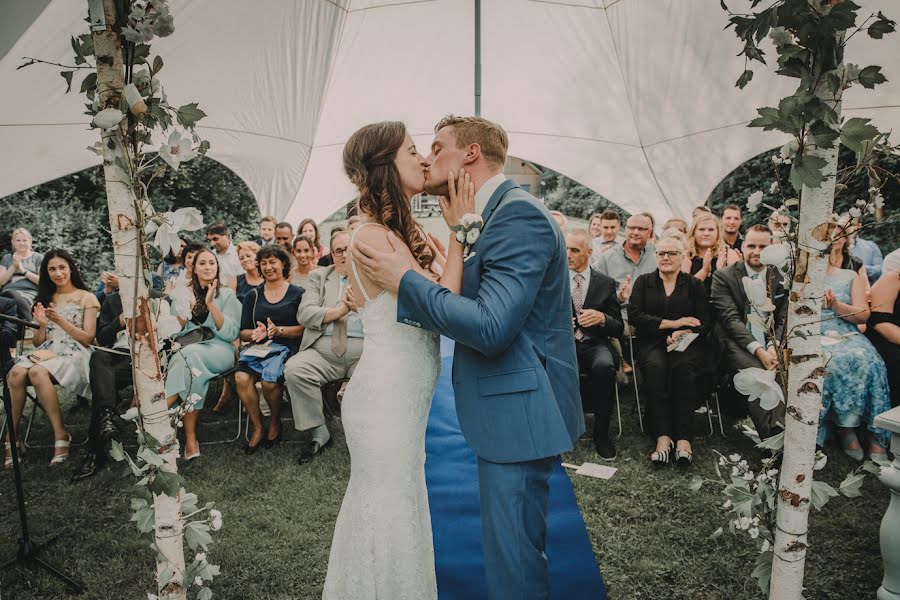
(769, 54, 842, 600)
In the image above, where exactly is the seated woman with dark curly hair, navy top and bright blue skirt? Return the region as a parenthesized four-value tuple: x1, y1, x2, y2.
(234, 245, 303, 454)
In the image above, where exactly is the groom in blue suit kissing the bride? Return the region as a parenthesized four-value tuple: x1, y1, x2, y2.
(354, 116, 584, 600)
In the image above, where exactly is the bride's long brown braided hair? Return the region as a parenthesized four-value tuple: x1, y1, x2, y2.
(344, 121, 434, 269)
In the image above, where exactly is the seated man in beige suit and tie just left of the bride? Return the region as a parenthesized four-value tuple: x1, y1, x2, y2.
(284, 232, 363, 464)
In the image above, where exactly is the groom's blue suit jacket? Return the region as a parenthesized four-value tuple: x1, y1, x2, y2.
(397, 180, 584, 463)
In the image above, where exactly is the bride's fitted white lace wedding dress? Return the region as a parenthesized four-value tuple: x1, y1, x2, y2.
(322, 230, 441, 600)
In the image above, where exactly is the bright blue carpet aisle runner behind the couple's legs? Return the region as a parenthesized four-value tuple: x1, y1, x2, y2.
(425, 339, 606, 600)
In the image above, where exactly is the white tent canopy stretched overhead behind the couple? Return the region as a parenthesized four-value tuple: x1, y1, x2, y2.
(0, 0, 900, 222)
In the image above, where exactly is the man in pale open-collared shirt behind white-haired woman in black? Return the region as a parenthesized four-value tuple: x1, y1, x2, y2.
(594, 213, 656, 304)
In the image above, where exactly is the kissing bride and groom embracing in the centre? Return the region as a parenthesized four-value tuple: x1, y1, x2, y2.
(322, 116, 584, 600)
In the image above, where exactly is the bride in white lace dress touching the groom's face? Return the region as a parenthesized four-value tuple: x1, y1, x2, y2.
(322, 122, 475, 600)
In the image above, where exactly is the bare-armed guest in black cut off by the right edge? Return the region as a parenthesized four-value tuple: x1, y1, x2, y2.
(866, 250, 900, 406)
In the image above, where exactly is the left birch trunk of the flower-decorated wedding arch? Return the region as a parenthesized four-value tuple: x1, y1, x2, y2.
(93, 0, 186, 599)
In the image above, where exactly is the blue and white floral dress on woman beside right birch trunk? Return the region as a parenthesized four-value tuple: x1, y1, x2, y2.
(817, 269, 891, 448)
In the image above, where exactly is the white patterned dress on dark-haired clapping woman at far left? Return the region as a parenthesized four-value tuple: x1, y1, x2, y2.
(16, 290, 100, 398)
